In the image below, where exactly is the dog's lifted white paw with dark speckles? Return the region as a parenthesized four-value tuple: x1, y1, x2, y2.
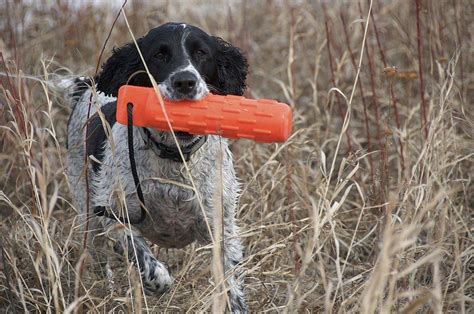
(141, 260, 174, 295)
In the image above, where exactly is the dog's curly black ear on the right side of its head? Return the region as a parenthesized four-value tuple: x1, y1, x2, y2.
(214, 37, 248, 96)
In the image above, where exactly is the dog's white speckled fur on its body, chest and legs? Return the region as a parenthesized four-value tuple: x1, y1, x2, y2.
(67, 91, 246, 312)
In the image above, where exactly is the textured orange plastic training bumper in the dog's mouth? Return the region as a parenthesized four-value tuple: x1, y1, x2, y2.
(117, 85, 292, 143)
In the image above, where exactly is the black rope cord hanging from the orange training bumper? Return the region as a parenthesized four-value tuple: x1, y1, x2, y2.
(94, 102, 146, 225)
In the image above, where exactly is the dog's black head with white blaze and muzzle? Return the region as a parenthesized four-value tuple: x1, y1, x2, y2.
(97, 23, 248, 144)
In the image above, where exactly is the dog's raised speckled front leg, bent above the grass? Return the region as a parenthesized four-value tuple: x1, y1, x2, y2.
(108, 224, 173, 295)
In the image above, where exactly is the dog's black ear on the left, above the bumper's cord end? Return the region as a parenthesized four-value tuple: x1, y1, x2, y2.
(96, 43, 143, 97)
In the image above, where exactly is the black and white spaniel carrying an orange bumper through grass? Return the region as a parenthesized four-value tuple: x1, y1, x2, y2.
(66, 23, 248, 313)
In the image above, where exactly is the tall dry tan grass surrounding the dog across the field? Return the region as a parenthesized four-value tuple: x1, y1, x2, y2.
(0, 0, 474, 313)
